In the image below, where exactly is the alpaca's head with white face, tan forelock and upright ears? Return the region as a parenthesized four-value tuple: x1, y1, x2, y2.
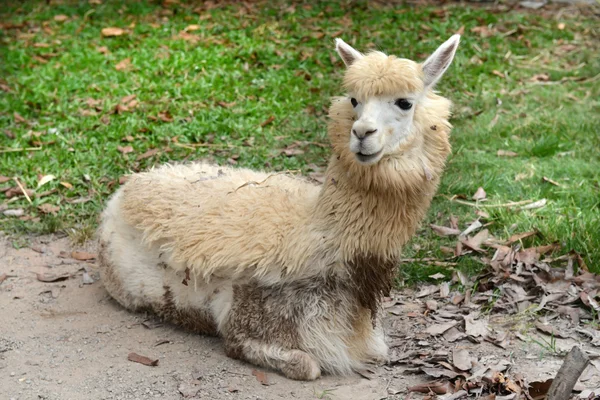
(336, 35, 460, 165)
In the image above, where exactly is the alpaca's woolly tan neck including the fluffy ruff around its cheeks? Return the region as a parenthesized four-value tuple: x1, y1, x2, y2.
(312, 93, 450, 264)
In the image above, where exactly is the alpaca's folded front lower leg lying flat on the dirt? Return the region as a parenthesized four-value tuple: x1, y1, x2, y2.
(225, 339, 321, 381)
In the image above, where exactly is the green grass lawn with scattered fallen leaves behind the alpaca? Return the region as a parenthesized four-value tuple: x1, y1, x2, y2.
(0, 0, 600, 280)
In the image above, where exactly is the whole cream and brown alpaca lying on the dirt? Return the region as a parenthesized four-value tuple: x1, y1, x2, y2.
(99, 35, 460, 380)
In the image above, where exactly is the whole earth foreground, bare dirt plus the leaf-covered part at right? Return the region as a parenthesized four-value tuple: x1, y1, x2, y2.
(0, 236, 600, 399)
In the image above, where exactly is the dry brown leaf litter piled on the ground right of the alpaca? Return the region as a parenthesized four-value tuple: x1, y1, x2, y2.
(383, 212, 600, 400)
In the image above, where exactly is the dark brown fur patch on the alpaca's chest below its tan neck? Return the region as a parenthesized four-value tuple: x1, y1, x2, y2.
(348, 255, 397, 326)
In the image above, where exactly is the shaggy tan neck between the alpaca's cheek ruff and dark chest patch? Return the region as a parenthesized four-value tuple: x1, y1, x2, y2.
(313, 156, 437, 263)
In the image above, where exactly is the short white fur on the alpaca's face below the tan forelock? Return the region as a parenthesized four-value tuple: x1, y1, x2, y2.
(348, 95, 417, 164)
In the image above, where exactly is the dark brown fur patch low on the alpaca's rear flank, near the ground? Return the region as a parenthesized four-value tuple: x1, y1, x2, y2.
(154, 286, 218, 336)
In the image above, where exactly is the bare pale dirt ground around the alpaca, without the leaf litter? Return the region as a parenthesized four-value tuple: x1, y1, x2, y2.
(0, 233, 600, 400)
